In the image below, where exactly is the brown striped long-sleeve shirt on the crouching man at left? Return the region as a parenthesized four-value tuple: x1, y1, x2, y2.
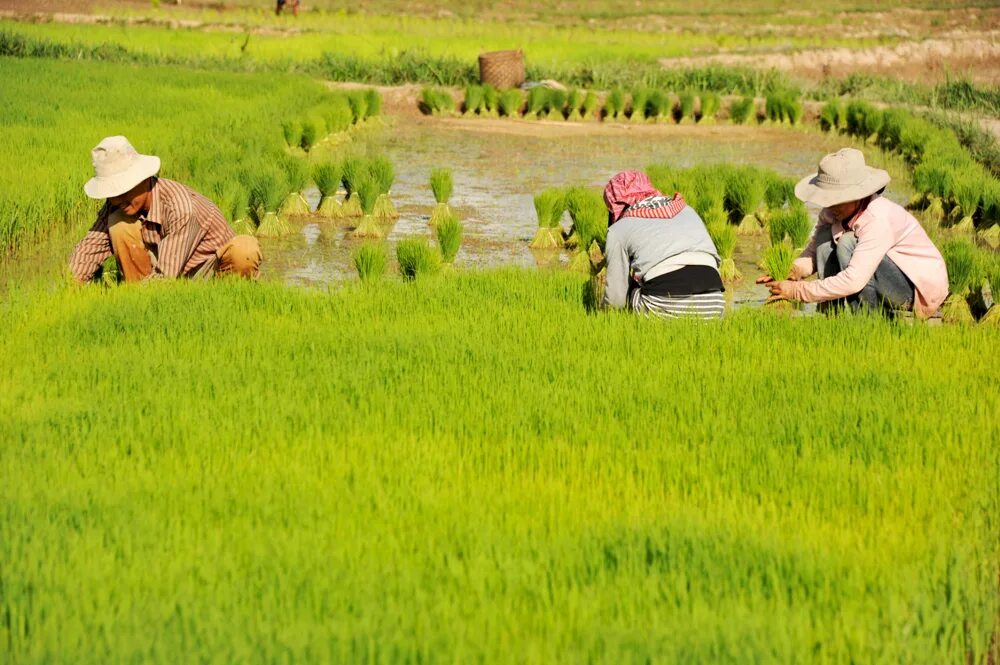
(69, 178, 234, 282)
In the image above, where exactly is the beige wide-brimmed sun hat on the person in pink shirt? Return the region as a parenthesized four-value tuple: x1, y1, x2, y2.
(795, 148, 890, 208)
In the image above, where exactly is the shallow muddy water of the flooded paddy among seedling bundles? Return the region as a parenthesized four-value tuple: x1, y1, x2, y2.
(263, 120, 906, 304)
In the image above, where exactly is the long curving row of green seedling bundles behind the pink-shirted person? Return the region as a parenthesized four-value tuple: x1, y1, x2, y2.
(820, 99, 1000, 236)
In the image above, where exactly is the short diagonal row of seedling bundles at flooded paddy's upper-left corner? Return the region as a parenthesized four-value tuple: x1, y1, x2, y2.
(281, 88, 382, 152)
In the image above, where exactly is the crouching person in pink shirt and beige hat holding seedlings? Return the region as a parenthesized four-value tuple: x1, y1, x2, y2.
(757, 148, 948, 318)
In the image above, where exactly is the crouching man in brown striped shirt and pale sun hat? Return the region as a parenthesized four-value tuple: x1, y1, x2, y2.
(69, 136, 261, 283)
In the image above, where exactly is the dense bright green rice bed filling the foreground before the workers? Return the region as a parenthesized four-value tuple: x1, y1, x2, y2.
(0, 272, 1000, 663)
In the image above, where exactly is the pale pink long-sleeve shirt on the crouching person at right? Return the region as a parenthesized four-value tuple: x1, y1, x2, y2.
(792, 197, 948, 318)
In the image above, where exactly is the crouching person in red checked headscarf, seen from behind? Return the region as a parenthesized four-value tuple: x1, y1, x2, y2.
(604, 171, 725, 319)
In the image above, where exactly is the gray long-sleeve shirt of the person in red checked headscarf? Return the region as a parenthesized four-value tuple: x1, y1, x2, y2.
(604, 206, 720, 308)
